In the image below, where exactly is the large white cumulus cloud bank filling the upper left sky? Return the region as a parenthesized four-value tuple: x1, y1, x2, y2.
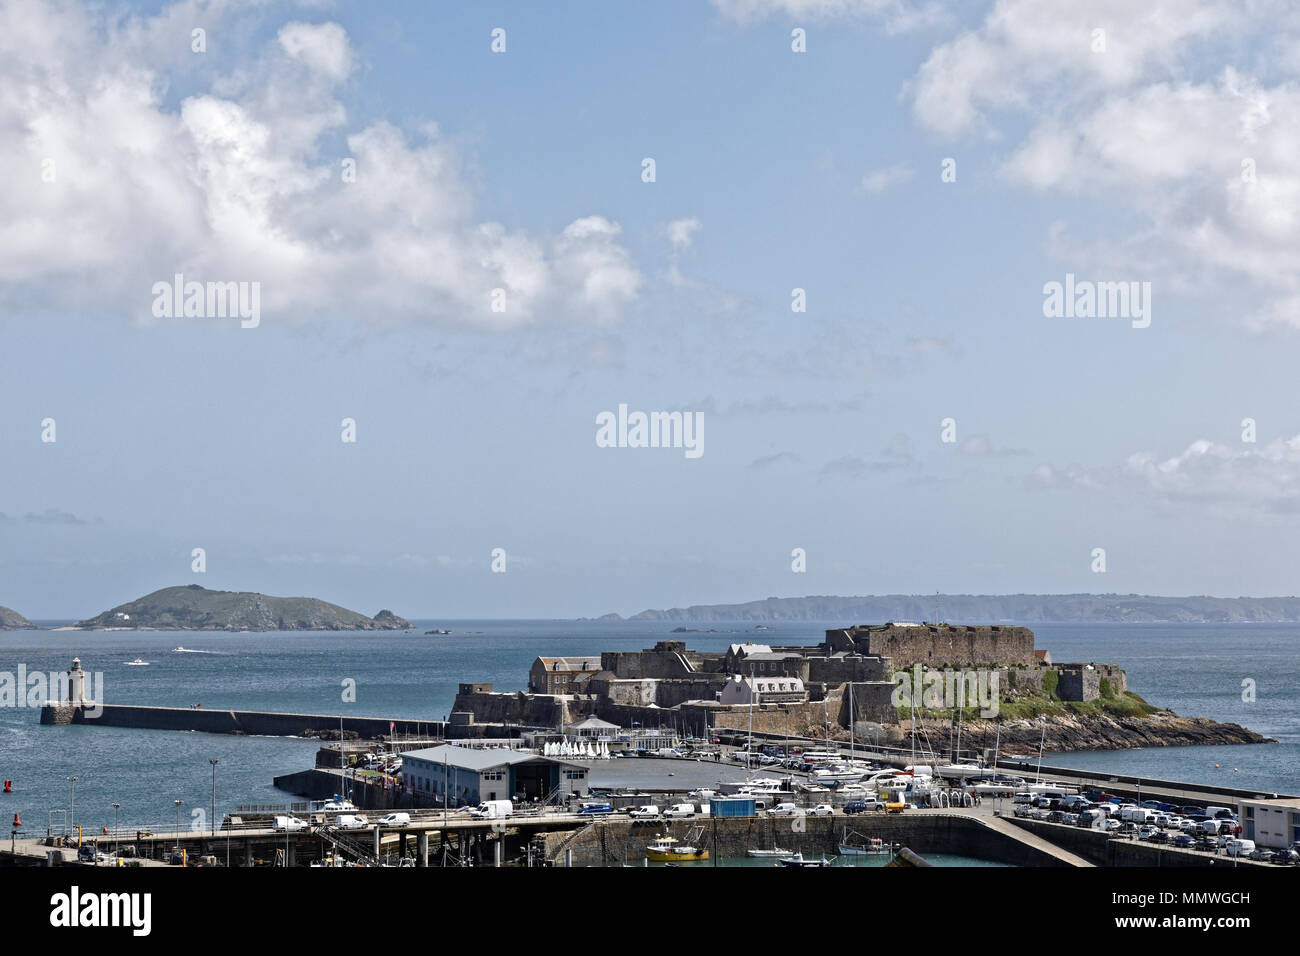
(0, 0, 642, 328)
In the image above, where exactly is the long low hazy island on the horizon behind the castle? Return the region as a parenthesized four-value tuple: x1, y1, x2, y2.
(608, 594, 1300, 624)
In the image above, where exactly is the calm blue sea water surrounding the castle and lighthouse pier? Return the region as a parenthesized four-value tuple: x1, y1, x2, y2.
(0, 620, 1300, 829)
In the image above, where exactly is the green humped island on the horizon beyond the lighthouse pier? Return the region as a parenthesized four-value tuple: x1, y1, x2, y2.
(74, 584, 412, 631)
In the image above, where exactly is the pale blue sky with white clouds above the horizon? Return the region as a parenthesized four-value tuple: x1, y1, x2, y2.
(0, 0, 1300, 619)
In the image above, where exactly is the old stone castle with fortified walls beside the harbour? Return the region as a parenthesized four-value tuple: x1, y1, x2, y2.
(452, 622, 1127, 736)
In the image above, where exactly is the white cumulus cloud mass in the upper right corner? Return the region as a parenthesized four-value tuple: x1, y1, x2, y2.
(909, 0, 1300, 328)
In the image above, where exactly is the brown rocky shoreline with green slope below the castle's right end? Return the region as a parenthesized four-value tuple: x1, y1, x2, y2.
(891, 710, 1277, 754)
